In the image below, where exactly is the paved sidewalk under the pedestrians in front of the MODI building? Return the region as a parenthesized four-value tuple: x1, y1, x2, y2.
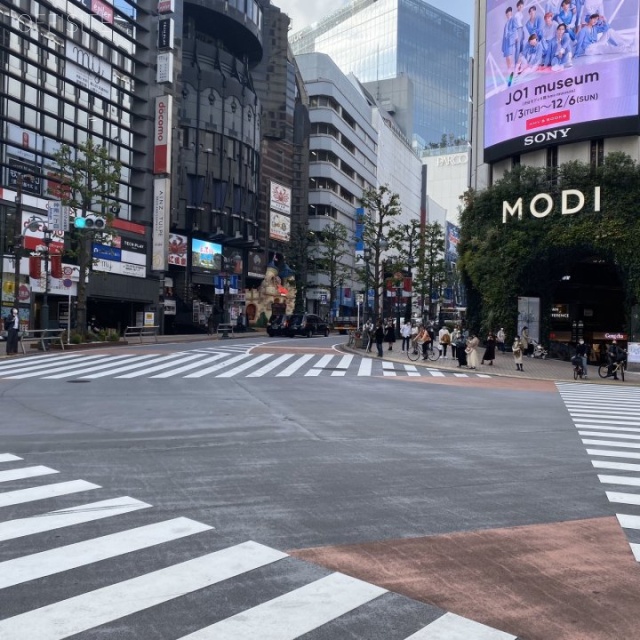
(344, 342, 640, 385)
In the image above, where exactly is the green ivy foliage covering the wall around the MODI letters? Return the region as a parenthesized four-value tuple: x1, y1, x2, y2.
(458, 153, 640, 335)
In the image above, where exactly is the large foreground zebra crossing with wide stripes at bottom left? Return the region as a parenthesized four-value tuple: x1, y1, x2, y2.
(0, 453, 515, 640)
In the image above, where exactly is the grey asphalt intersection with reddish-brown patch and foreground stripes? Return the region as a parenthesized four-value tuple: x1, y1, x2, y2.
(0, 337, 640, 640)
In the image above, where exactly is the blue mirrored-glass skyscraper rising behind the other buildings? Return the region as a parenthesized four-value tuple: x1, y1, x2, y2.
(290, 0, 470, 149)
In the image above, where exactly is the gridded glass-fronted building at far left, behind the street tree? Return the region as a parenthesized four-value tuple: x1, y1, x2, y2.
(0, 0, 158, 328)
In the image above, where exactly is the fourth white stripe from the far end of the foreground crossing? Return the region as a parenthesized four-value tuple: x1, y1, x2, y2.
(0, 496, 151, 540)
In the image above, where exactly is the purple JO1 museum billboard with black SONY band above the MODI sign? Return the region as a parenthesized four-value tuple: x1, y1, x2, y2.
(484, 0, 640, 162)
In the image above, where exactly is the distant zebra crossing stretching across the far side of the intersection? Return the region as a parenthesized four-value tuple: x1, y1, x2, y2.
(0, 345, 491, 380)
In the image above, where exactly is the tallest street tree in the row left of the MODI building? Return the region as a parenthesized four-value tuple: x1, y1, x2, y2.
(356, 185, 402, 317)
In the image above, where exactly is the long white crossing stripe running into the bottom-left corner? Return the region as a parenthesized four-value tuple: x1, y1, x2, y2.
(0, 542, 287, 640)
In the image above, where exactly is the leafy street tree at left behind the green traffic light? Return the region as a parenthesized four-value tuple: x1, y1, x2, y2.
(49, 138, 122, 338)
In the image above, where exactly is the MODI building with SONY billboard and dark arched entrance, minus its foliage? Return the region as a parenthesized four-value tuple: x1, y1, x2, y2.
(471, 0, 640, 345)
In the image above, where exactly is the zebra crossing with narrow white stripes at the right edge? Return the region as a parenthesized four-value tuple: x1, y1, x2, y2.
(556, 382, 640, 562)
